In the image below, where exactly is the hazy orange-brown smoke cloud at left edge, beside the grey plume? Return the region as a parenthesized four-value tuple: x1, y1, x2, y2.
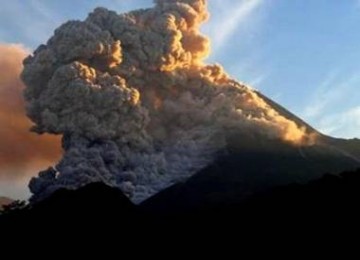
(0, 44, 60, 179)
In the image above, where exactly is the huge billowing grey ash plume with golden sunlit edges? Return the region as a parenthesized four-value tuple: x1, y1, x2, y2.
(22, 0, 305, 202)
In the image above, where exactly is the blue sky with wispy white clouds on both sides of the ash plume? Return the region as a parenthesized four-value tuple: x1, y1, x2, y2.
(0, 0, 360, 138)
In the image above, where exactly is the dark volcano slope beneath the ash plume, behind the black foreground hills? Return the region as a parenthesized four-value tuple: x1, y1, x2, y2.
(144, 128, 360, 212)
